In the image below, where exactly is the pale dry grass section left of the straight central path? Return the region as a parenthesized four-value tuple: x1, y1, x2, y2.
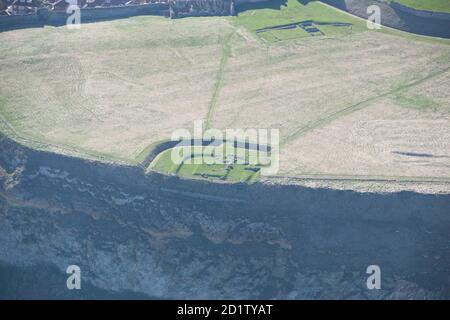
(0, 18, 229, 159)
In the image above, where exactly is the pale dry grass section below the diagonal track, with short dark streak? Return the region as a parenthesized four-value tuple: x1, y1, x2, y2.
(280, 98, 450, 179)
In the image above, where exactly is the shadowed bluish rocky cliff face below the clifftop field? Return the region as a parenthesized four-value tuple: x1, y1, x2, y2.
(0, 137, 450, 299)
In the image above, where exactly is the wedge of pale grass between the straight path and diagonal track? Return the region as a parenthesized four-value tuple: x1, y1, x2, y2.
(213, 32, 450, 140)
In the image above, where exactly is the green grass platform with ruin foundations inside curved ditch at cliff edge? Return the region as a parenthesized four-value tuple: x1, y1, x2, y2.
(149, 144, 268, 183)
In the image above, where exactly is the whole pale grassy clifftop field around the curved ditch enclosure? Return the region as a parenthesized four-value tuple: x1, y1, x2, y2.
(0, 0, 450, 185)
